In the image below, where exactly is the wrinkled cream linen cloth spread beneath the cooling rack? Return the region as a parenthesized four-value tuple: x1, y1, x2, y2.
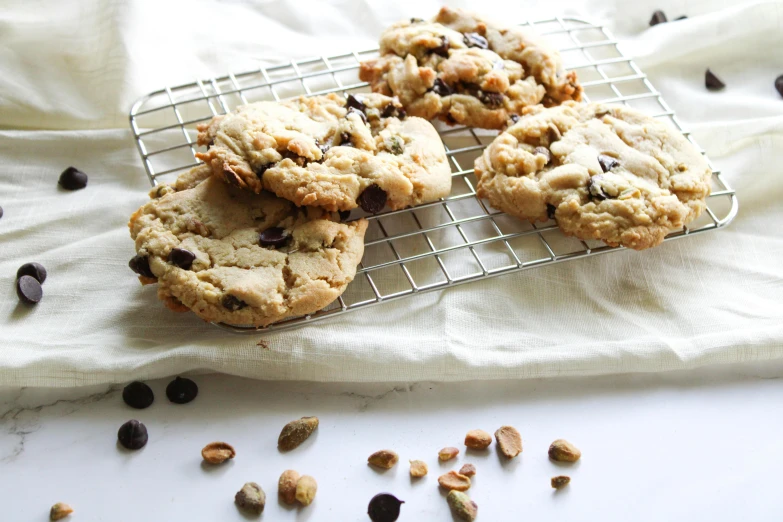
(0, 0, 783, 386)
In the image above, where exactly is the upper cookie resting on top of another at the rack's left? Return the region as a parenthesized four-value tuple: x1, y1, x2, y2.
(197, 93, 451, 213)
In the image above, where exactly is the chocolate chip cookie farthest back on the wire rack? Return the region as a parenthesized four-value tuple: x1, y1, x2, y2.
(359, 7, 582, 129)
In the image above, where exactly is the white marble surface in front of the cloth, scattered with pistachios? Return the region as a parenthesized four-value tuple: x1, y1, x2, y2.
(0, 364, 783, 522)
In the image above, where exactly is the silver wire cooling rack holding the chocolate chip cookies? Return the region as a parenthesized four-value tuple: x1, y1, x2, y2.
(130, 17, 738, 333)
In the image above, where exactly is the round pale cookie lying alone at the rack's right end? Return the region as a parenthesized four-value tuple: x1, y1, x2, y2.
(475, 102, 711, 250)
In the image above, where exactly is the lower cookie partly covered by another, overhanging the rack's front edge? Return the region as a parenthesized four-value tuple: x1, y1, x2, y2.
(128, 166, 367, 326)
